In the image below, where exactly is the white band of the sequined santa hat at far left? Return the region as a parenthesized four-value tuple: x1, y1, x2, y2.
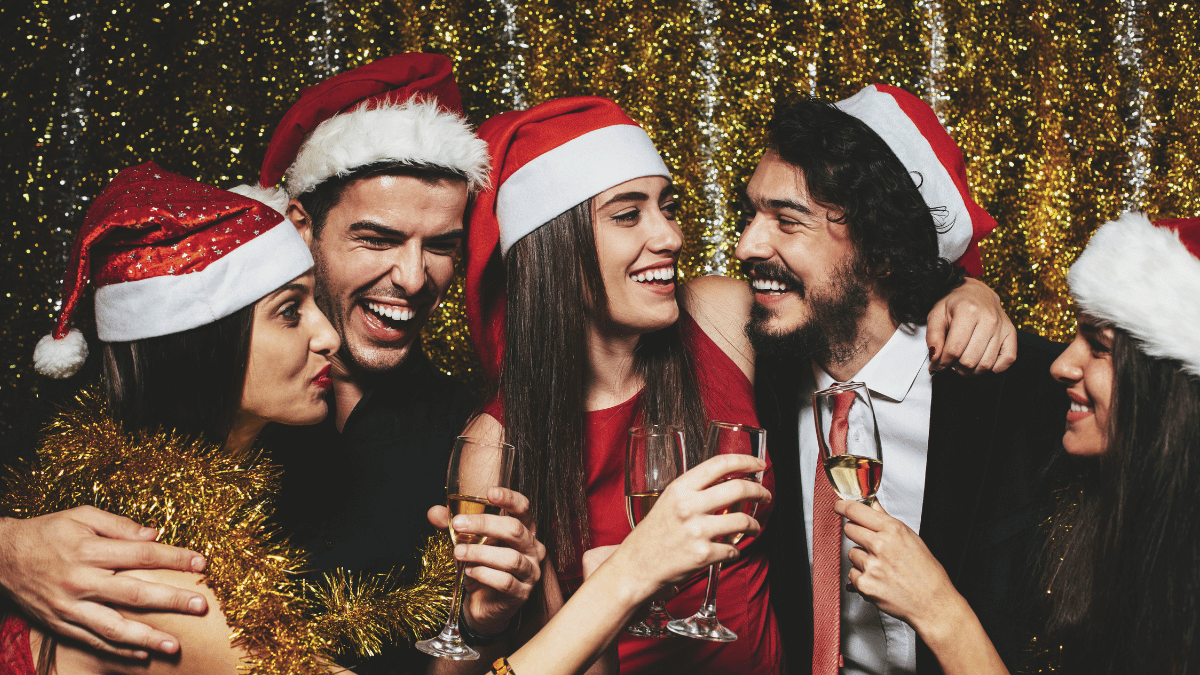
(96, 219, 312, 342)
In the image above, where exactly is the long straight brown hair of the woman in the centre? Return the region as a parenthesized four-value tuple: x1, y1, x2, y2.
(499, 199, 706, 569)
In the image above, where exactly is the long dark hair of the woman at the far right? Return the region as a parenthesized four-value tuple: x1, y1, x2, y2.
(1043, 328, 1200, 675)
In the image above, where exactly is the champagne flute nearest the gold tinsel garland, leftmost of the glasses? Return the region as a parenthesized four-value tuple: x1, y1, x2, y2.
(416, 436, 514, 661)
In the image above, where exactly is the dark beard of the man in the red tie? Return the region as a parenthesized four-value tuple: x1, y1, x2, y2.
(745, 255, 870, 364)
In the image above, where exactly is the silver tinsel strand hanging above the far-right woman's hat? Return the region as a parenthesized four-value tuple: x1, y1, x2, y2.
(1116, 0, 1154, 211)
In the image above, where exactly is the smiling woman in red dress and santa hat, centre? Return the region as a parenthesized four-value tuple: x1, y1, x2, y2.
(467, 97, 1012, 673)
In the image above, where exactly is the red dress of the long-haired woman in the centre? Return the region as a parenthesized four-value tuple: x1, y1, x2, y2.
(485, 317, 782, 675)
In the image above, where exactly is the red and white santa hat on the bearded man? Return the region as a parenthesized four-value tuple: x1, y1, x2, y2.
(834, 84, 996, 276)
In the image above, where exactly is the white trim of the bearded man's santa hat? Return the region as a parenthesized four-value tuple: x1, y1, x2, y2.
(834, 84, 974, 261)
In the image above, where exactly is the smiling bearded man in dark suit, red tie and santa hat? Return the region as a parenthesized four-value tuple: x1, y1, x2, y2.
(737, 85, 1066, 675)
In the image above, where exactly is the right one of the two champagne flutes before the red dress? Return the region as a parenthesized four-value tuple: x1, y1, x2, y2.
(667, 422, 767, 643)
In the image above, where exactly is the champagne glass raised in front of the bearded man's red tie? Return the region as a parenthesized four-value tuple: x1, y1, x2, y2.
(812, 382, 883, 506)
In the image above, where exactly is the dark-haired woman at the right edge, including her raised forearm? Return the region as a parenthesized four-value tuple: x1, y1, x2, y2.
(838, 214, 1200, 674)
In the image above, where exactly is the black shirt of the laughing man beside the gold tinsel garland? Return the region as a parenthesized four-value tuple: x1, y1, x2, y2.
(264, 351, 479, 675)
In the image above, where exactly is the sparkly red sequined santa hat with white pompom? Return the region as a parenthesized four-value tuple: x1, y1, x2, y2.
(34, 162, 312, 377)
